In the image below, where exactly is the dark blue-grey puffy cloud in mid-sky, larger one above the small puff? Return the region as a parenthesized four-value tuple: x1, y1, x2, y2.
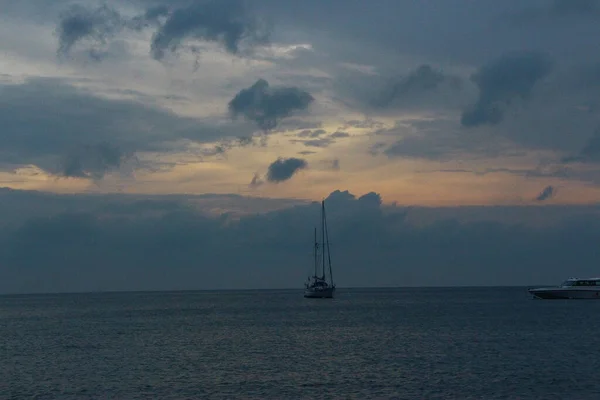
(228, 79, 314, 130)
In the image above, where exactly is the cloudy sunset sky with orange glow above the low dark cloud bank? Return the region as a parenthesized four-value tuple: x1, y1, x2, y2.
(0, 0, 600, 291)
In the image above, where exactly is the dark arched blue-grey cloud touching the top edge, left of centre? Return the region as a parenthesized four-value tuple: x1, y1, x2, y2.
(151, 0, 270, 60)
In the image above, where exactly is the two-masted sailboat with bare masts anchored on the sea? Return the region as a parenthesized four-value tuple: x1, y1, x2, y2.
(304, 200, 335, 299)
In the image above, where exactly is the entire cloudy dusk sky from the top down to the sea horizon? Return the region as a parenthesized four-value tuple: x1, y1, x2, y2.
(0, 0, 600, 293)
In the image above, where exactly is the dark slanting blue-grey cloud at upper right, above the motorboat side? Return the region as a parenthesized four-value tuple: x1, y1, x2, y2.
(461, 51, 553, 127)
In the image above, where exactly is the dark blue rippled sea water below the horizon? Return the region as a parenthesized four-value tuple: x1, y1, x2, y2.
(0, 288, 600, 399)
